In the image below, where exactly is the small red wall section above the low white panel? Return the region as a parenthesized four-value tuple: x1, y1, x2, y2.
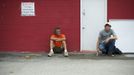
(108, 0, 134, 19)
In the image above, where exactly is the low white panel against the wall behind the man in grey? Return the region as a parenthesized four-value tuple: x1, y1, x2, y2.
(109, 19, 134, 53)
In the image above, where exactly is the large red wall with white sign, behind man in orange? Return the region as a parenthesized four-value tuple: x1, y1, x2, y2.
(0, 0, 80, 52)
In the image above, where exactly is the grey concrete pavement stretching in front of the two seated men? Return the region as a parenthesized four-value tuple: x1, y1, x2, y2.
(0, 53, 134, 75)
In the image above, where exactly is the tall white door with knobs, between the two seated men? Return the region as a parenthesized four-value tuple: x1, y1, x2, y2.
(81, 0, 107, 50)
